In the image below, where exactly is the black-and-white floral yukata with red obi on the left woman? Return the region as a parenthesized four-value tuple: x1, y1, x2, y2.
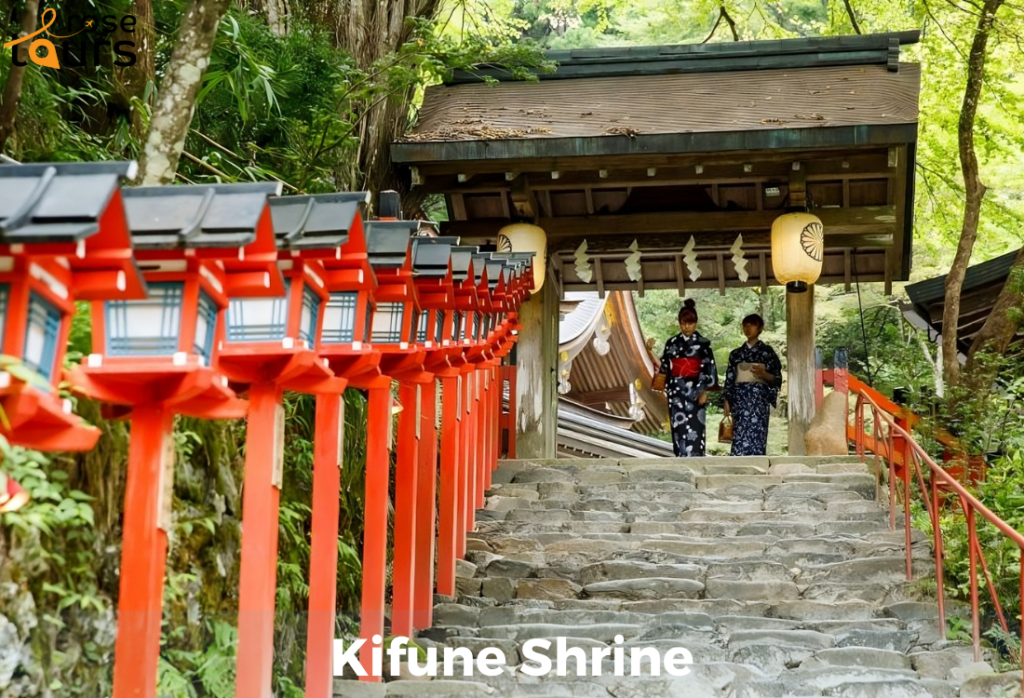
(658, 332, 718, 457)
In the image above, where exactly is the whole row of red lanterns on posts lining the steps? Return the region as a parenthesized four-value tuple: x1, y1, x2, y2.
(0, 163, 532, 698)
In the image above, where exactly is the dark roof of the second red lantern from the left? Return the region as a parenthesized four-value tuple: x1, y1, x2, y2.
(123, 182, 282, 250)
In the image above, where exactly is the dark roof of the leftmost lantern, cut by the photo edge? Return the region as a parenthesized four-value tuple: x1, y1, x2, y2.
(0, 161, 138, 245)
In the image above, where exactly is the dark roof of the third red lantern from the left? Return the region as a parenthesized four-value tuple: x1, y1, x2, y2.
(270, 191, 370, 250)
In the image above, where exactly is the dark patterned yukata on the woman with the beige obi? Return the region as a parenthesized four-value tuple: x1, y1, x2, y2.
(724, 340, 782, 455)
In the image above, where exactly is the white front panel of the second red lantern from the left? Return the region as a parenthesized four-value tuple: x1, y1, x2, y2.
(105, 281, 185, 356)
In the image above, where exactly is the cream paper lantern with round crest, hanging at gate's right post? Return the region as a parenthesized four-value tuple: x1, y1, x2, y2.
(771, 213, 825, 293)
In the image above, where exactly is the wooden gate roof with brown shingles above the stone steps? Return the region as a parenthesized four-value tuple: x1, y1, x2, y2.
(391, 32, 922, 295)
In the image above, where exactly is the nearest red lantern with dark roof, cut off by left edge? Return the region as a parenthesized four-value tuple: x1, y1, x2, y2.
(0, 162, 145, 450)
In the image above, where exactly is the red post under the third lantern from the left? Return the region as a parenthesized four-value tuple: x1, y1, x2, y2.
(234, 384, 285, 698)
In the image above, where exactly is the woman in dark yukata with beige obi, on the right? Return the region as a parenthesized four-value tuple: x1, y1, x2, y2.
(724, 314, 782, 455)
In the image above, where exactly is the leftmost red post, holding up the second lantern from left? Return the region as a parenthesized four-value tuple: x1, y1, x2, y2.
(114, 404, 174, 698)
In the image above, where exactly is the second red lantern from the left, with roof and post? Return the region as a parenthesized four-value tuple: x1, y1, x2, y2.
(72, 184, 283, 698)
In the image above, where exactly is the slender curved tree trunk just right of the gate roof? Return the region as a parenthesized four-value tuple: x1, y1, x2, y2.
(942, 0, 1005, 386)
